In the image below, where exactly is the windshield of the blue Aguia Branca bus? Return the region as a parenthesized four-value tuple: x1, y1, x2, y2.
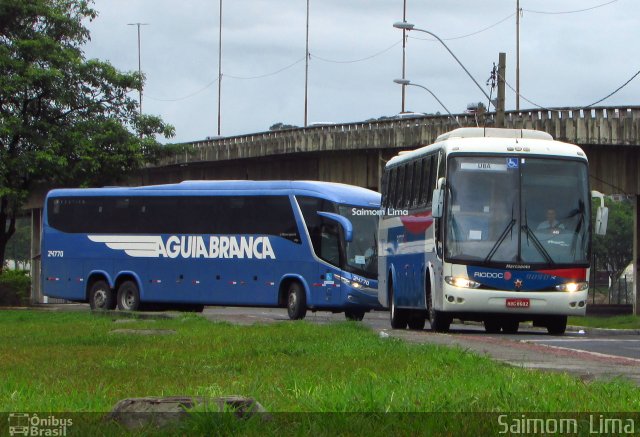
(338, 205, 378, 278)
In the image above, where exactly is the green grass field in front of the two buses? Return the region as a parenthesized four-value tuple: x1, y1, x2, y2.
(0, 311, 640, 435)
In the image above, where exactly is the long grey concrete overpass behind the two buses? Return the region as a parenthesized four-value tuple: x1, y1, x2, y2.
(31, 106, 640, 311)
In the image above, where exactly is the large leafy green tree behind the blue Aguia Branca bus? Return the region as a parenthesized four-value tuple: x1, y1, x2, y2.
(0, 0, 174, 269)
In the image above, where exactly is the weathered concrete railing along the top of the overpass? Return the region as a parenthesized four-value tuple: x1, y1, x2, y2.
(157, 106, 640, 166)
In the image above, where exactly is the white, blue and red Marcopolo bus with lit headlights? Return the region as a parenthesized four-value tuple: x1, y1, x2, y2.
(378, 128, 606, 334)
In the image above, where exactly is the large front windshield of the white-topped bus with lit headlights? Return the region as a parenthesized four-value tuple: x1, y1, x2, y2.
(445, 155, 590, 267)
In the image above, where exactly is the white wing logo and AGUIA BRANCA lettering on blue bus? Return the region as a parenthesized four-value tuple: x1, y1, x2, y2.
(88, 235, 276, 259)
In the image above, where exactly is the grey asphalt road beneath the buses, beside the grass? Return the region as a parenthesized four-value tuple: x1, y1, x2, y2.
(204, 307, 640, 385)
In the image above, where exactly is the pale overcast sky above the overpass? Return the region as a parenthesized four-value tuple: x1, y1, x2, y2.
(85, 0, 640, 142)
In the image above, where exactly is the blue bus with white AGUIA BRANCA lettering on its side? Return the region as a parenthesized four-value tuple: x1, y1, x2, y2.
(42, 181, 380, 320)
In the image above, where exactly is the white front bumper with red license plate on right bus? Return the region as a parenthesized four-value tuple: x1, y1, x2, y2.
(442, 284, 588, 316)
